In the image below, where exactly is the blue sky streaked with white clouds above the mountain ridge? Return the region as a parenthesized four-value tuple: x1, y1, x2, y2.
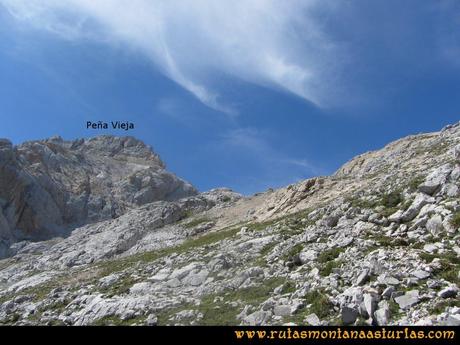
(0, 0, 460, 194)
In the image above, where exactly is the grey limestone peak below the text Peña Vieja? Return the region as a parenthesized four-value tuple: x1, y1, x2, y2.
(0, 136, 197, 256)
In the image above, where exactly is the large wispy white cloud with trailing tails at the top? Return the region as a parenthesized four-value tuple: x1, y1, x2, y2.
(0, 0, 335, 114)
